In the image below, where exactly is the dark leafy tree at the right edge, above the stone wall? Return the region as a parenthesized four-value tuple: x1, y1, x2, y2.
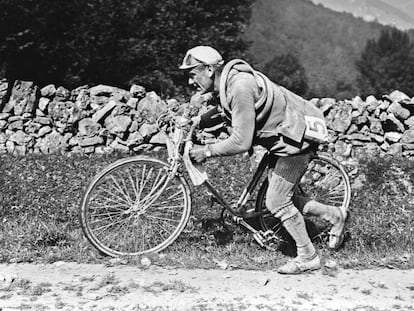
(356, 28, 414, 97)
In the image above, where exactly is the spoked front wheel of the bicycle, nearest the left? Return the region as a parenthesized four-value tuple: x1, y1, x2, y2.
(80, 156, 191, 257)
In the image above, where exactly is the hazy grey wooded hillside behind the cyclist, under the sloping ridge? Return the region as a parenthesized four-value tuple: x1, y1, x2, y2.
(245, 0, 385, 98)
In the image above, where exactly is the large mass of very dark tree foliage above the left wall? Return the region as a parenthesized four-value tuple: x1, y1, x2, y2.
(0, 0, 252, 93)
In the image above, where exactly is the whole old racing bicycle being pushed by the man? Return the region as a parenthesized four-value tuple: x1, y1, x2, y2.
(80, 112, 351, 257)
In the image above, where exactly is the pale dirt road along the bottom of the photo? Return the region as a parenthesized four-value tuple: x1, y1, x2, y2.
(0, 262, 414, 311)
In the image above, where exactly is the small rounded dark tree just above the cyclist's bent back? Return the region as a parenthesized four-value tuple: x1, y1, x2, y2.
(263, 53, 308, 96)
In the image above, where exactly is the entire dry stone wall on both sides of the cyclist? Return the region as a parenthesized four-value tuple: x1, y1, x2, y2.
(0, 80, 414, 160)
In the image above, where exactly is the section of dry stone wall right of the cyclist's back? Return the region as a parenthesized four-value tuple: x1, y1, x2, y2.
(312, 91, 414, 159)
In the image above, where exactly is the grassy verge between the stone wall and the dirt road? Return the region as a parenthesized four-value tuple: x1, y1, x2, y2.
(0, 154, 414, 269)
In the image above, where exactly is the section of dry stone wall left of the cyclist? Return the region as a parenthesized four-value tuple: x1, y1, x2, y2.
(0, 81, 175, 155)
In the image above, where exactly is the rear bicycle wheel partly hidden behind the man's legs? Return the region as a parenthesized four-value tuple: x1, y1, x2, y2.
(256, 154, 351, 239)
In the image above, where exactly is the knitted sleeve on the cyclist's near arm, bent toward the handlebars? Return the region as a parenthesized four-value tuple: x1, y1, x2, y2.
(210, 76, 257, 156)
